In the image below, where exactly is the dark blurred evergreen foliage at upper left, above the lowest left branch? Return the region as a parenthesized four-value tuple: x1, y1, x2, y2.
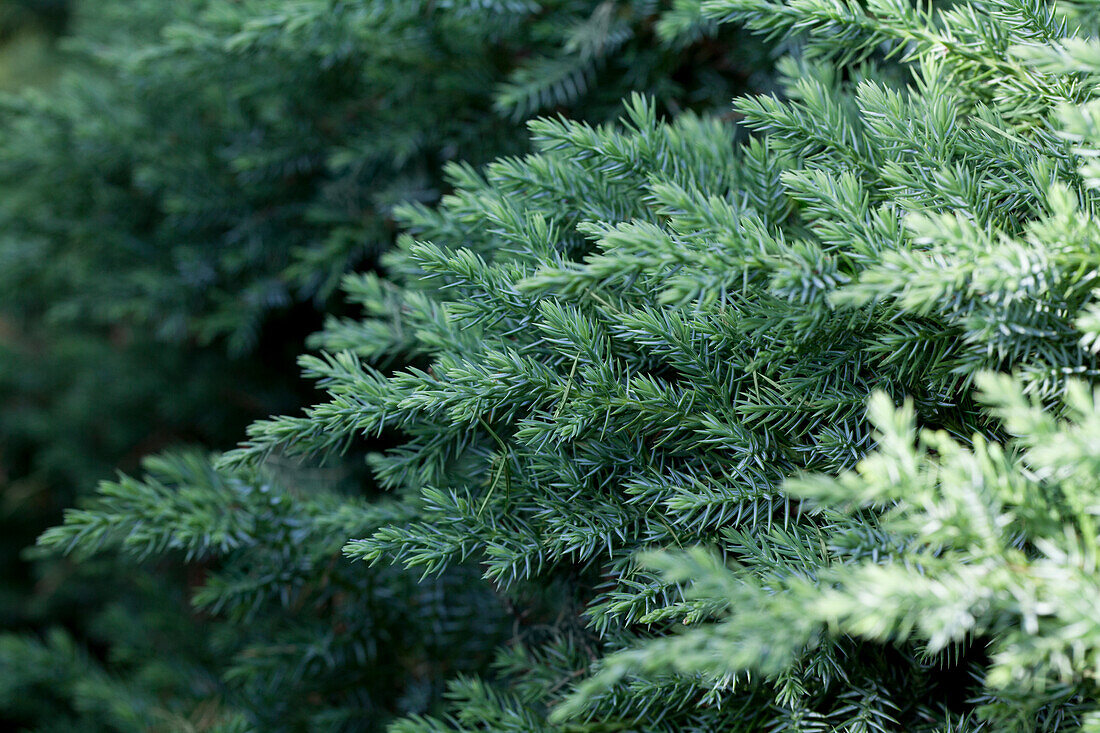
(0, 0, 766, 572)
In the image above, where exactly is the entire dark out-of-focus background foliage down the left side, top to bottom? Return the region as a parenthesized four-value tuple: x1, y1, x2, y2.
(0, 0, 770, 731)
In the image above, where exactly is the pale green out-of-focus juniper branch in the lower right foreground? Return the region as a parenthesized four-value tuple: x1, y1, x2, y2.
(558, 373, 1100, 731)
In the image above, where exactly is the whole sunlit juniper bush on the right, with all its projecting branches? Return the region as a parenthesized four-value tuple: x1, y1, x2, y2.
(41, 0, 1100, 733)
